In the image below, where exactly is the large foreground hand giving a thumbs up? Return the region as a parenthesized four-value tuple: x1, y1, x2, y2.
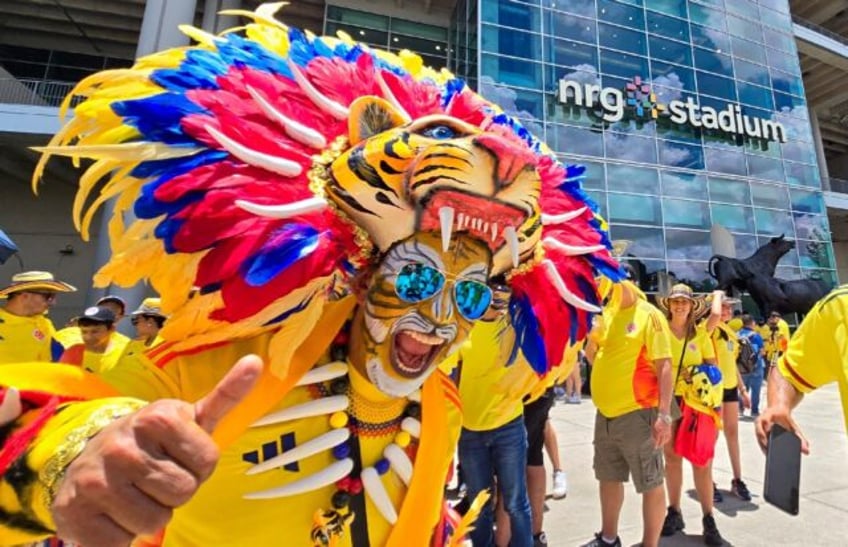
(52, 355, 262, 547)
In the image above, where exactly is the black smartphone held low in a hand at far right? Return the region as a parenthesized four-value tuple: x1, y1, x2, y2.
(763, 424, 801, 515)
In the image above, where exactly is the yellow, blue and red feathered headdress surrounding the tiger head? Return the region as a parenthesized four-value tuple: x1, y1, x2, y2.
(33, 4, 620, 374)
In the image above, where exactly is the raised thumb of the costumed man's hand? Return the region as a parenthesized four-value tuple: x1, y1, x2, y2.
(194, 355, 262, 433)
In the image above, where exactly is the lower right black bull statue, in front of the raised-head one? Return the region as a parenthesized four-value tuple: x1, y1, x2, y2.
(746, 275, 831, 317)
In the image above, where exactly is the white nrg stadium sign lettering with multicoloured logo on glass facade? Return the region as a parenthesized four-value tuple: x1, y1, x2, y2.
(559, 76, 786, 146)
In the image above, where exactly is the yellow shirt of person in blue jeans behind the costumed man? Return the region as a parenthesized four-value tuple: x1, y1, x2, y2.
(440, 320, 529, 431)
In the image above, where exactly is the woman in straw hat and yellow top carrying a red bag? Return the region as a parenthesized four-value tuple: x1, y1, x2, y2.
(657, 283, 722, 545)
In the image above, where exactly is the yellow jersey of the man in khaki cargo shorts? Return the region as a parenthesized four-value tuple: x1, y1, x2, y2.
(592, 299, 671, 418)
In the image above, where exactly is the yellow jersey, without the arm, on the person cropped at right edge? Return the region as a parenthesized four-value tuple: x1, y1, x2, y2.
(779, 285, 848, 432)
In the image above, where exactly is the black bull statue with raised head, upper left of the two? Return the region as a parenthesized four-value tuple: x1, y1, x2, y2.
(707, 234, 795, 295)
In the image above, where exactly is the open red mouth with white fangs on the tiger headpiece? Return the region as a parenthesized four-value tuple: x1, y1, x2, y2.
(421, 190, 527, 252)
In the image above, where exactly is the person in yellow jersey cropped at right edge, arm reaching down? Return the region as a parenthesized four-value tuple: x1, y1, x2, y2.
(755, 285, 848, 454)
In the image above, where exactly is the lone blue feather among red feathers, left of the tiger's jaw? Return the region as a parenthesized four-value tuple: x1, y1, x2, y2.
(242, 224, 321, 287)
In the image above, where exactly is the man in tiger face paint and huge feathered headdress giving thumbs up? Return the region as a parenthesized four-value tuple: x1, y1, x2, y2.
(0, 4, 618, 546)
